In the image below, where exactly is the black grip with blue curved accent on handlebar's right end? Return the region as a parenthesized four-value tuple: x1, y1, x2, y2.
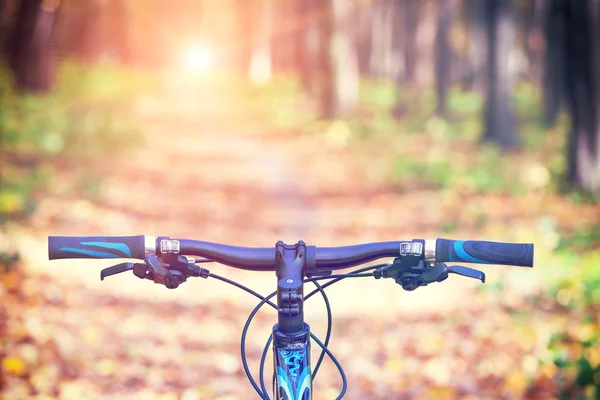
(435, 239, 533, 267)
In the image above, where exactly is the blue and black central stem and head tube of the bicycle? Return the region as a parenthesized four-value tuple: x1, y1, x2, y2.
(273, 241, 313, 400)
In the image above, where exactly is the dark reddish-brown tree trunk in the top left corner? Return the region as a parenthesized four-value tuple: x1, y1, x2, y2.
(8, 0, 60, 92)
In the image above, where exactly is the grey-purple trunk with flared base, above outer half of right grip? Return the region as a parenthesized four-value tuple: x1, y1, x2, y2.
(483, 0, 517, 149)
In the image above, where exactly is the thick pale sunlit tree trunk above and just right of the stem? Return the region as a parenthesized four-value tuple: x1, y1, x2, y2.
(321, 0, 359, 118)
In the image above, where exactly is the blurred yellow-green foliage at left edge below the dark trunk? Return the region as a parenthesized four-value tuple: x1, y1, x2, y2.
(0, 63, 152, 221)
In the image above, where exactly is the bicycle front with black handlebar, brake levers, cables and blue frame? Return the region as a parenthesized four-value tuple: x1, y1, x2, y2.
(48, 235, 534, 400)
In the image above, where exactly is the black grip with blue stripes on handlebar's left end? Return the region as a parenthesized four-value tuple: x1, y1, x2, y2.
(48, 235, 146, 260)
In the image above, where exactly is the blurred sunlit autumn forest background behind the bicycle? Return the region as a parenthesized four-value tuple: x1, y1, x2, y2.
(0, 0, 600, 400)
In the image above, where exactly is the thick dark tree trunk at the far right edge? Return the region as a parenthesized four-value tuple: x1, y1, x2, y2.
(561, 0, 600, 192)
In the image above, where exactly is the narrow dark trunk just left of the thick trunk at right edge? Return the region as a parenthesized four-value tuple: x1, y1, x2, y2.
(542, 0, 566, 127)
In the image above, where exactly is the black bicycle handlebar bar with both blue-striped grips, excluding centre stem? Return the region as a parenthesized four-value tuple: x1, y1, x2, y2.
(48, 235, 533, 271)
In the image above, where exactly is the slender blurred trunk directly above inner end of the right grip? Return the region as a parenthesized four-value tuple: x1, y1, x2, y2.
(435, 0, 453, 117)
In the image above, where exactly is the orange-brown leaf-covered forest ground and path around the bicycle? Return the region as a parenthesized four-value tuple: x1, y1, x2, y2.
(0, 74, 600, 400)
